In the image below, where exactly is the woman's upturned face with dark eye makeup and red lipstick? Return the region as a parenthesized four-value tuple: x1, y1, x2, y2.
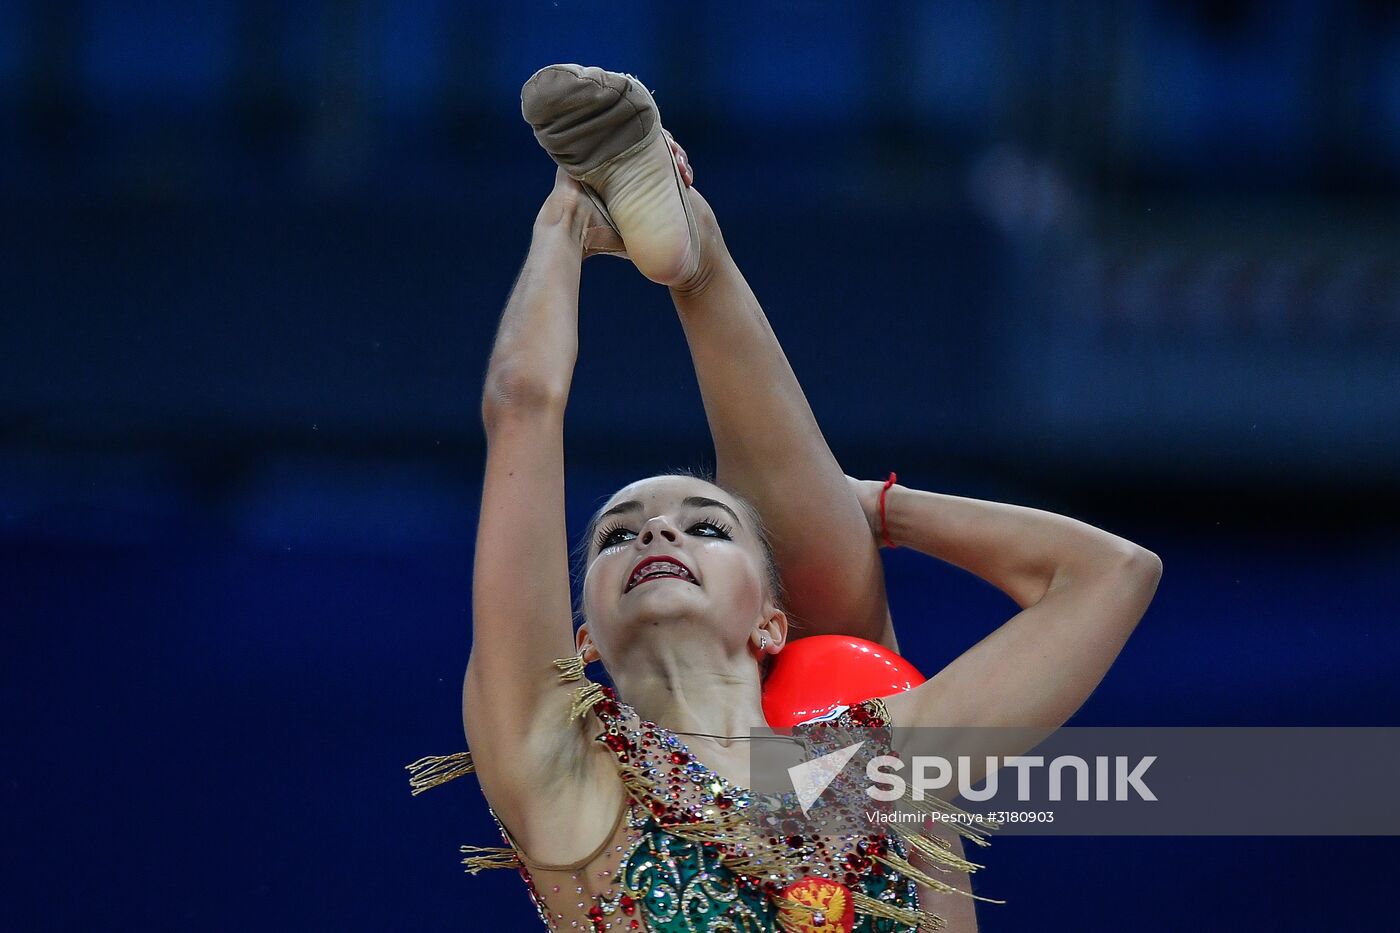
(584, 476, 781, 661)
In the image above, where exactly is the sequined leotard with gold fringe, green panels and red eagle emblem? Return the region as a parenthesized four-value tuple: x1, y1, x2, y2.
(409, 660, 984, 933)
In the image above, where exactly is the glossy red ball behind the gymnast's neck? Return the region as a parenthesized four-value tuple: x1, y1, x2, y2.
(763, 635, 925, 728)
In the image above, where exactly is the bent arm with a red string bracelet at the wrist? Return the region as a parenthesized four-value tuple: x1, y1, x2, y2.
(855, 482, 1162, 728)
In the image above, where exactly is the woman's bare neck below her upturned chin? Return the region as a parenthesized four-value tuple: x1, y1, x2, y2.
(612, 639, 767, 738)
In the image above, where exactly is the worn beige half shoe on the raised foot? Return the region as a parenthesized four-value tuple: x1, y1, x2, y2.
(521, 64, 700, 286)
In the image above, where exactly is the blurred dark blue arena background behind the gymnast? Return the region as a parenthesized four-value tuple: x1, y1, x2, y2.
(0, 0, 1400, 933)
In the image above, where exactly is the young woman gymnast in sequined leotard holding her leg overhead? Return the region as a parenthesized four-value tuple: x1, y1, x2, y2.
(410, 66, 1161, 932)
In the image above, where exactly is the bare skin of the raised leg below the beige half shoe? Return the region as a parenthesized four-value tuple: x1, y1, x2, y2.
(671, 182, 895, 647)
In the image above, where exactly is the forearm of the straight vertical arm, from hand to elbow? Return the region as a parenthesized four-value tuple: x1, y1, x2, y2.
(482, 198, 582, 427)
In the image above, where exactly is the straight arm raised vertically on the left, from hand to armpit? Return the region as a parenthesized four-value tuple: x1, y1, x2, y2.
(462, 172, 621, 860)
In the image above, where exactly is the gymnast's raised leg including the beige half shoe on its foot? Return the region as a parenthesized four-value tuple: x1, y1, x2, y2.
(521, 64, 893, 646)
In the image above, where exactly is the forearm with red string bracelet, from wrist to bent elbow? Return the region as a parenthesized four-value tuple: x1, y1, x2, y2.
(876, 483, 1142, 608)
